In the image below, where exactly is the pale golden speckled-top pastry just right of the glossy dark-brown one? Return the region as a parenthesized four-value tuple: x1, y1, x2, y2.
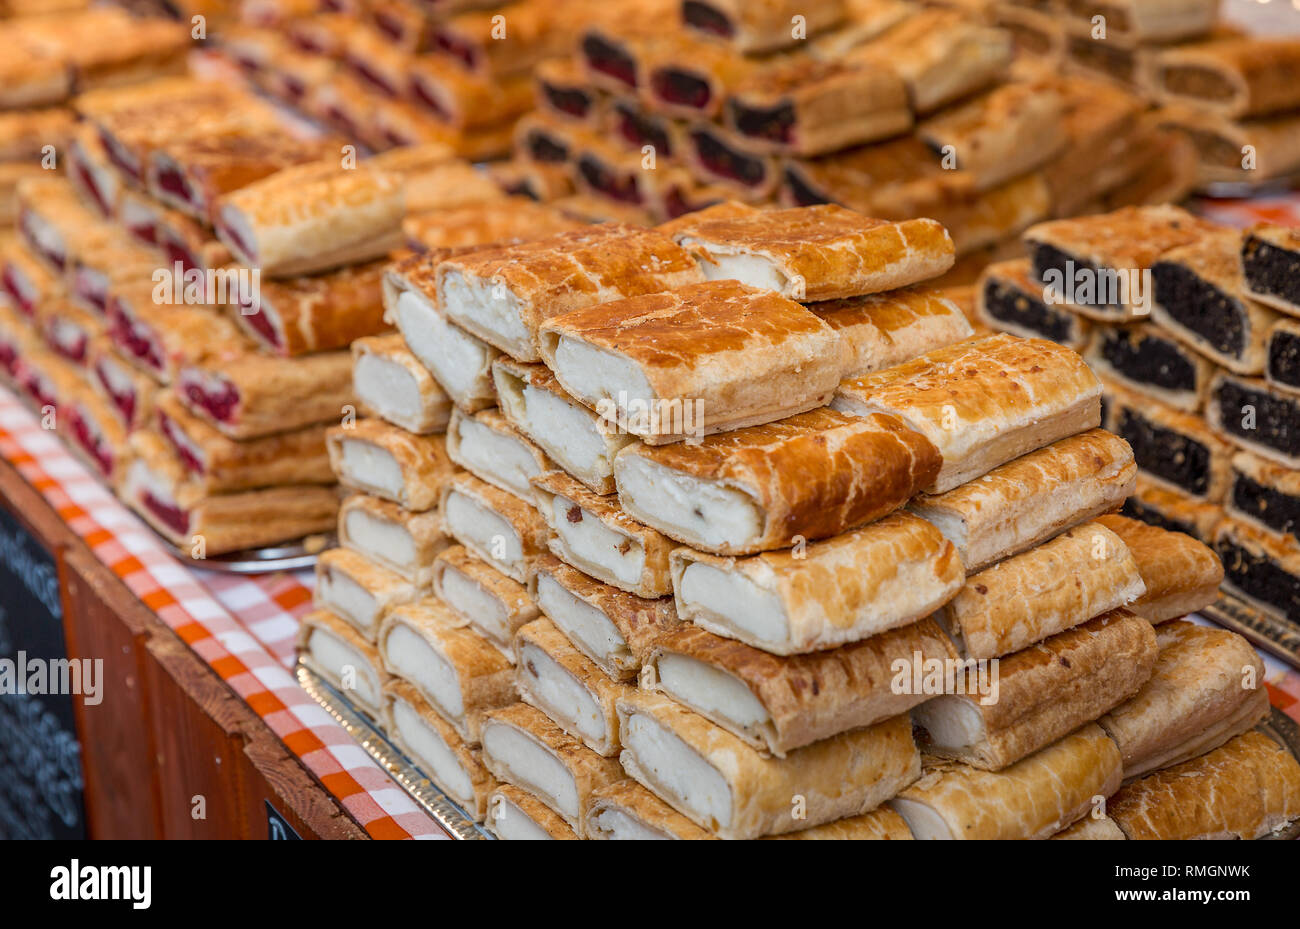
(832, 334, 1101, 494)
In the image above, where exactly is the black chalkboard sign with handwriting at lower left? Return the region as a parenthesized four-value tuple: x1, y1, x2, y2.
(0, 507, 86, 839)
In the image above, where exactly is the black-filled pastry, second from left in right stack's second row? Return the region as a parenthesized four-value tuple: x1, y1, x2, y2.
(1084, 322, 1214, 413)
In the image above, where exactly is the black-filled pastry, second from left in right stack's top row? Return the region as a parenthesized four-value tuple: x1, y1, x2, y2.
(1151, 229, 1278, 374)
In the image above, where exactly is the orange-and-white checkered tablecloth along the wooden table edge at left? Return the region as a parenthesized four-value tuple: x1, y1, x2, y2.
(0, 387, 450, 838)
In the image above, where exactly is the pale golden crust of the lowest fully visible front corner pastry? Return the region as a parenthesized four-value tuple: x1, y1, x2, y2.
(619, 691, 920, 839)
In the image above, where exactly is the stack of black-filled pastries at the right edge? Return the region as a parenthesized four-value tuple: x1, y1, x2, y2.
(978, 207, 1300, 636)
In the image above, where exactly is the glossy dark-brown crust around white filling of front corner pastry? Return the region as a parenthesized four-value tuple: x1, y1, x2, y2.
(615, 408, 940, 555)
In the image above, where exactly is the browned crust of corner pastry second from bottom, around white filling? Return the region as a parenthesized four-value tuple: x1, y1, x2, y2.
(647, 618, 957, 757)
